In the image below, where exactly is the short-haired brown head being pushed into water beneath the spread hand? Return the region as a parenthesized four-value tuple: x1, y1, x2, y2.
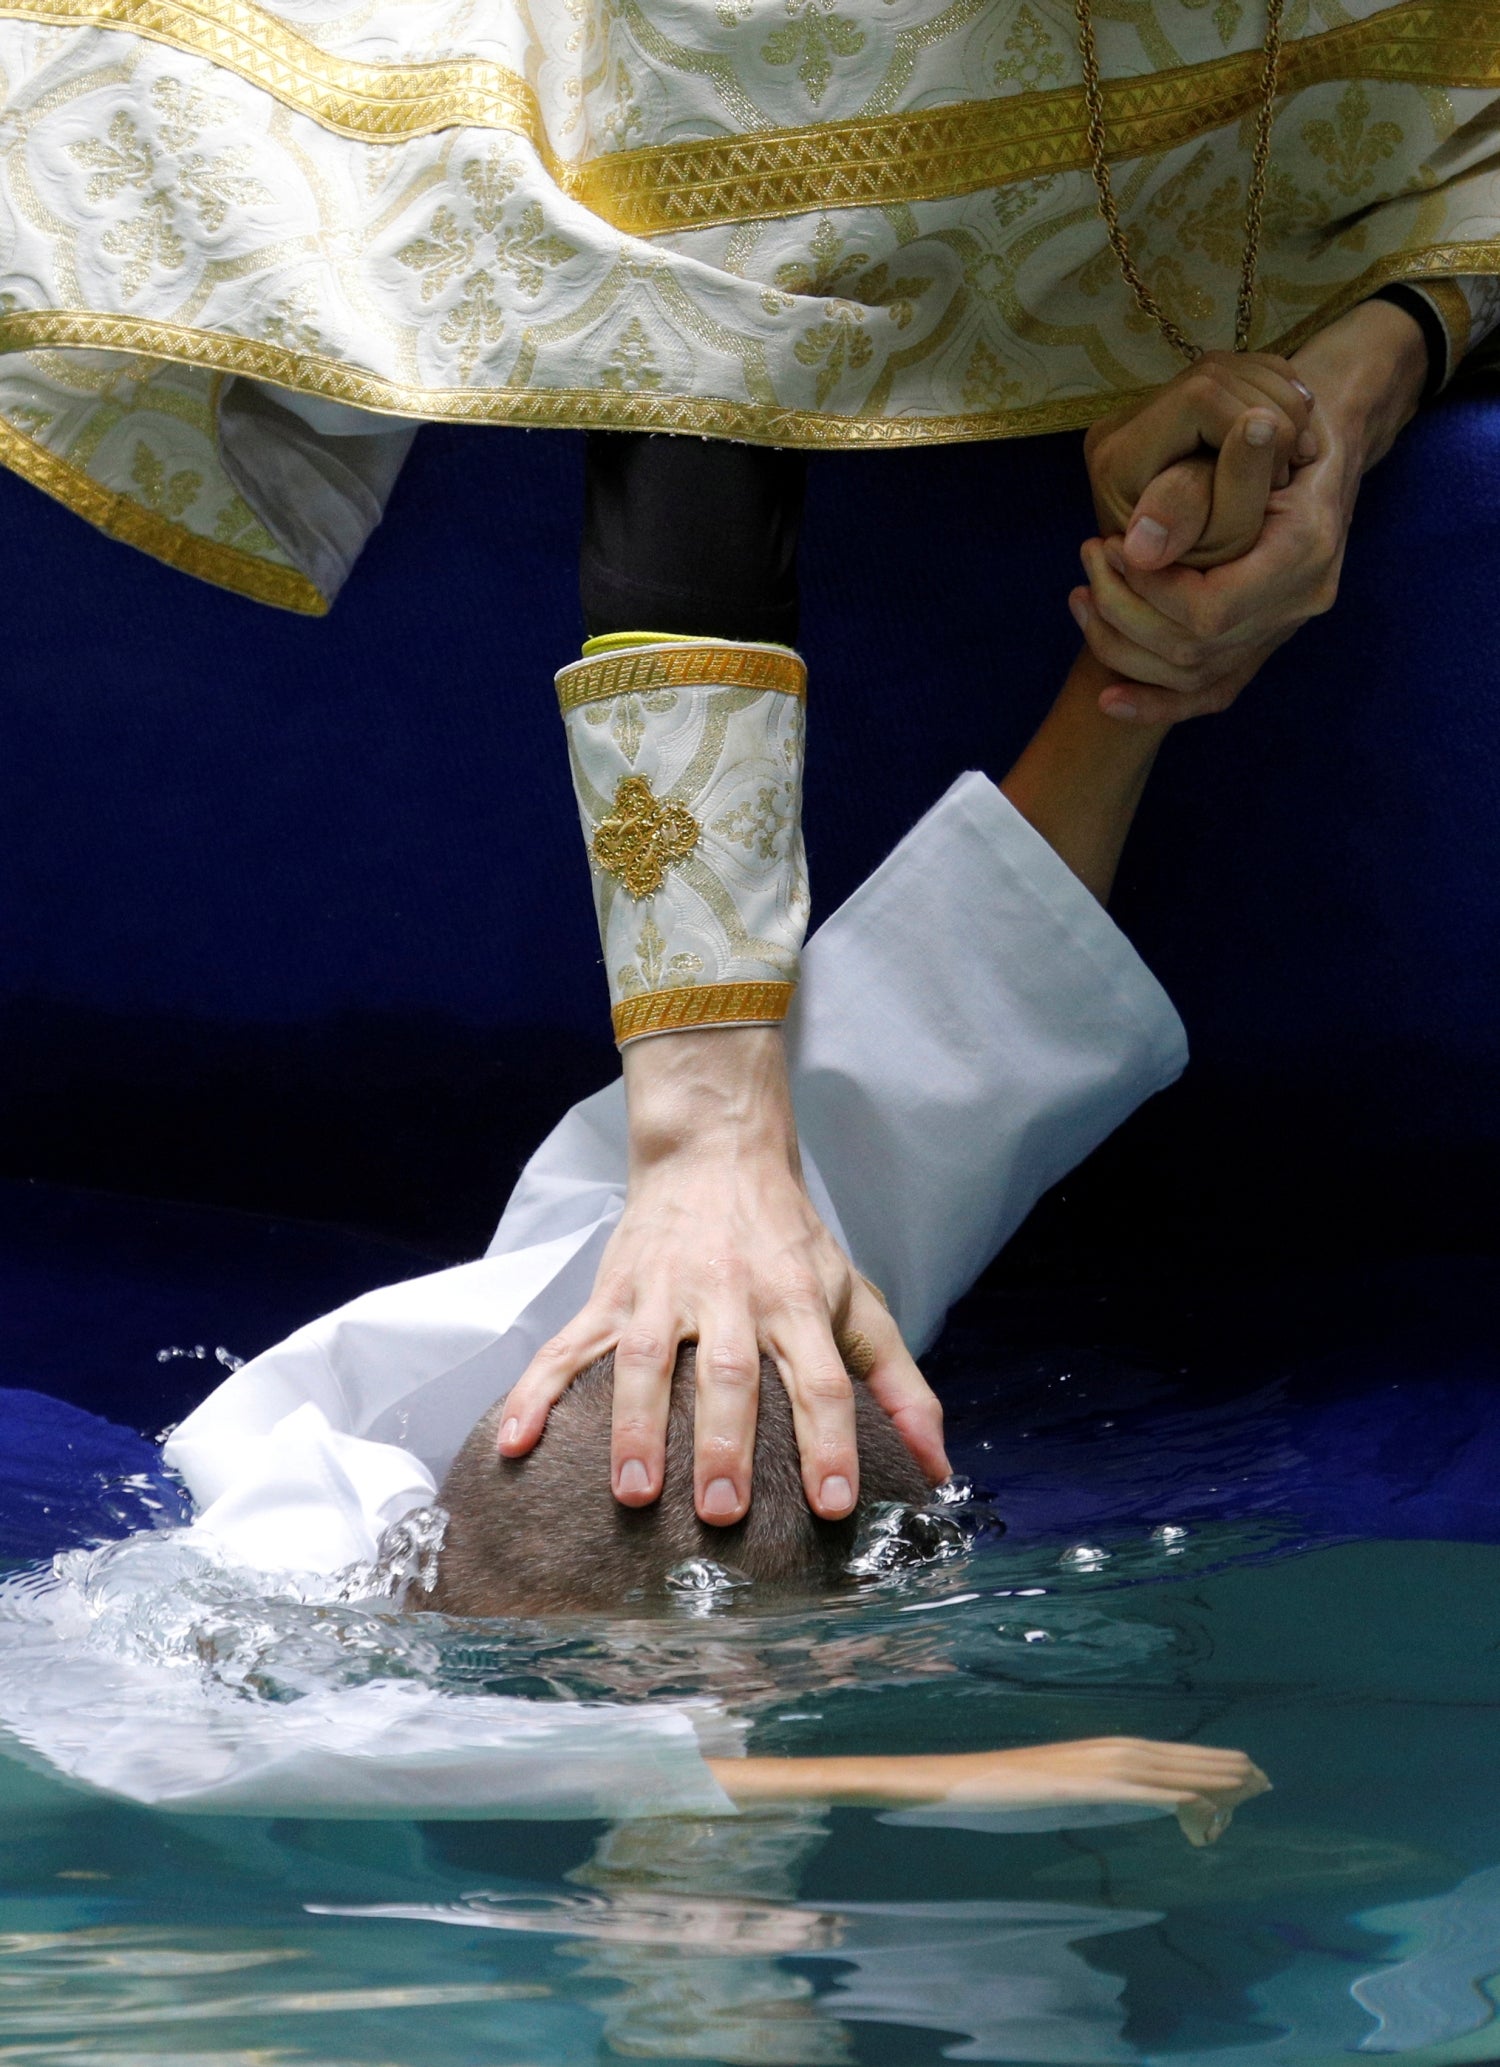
(426, 1344, 930, 1616)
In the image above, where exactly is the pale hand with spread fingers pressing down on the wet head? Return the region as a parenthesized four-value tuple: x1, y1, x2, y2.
(500, 1027, 948, 1525)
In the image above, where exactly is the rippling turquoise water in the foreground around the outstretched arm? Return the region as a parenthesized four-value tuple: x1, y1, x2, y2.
(0, 1521, 1500, 2067)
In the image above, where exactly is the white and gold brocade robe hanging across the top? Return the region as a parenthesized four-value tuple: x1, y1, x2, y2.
(0, 0, 1500, 612)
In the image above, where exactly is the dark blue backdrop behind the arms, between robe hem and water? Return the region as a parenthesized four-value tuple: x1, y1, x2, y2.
(0, 393, 1500, 1275)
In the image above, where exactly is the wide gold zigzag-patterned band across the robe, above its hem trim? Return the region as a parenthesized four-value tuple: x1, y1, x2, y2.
(0, 0, 1500, 238)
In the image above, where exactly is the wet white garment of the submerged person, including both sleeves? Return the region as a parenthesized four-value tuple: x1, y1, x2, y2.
(0, 775, 1186, 1819)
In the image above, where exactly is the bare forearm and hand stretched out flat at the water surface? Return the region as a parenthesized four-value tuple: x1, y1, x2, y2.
(709, 1736, 1271, 1844)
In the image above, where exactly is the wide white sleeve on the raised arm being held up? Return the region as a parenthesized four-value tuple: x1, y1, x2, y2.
(791, 775, 1188, 1352)
